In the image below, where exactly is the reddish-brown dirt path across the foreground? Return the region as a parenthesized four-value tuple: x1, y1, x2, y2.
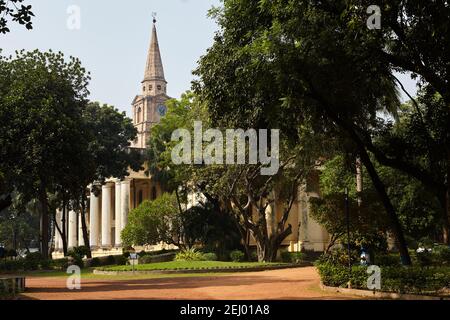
(21, 267, 355, 300)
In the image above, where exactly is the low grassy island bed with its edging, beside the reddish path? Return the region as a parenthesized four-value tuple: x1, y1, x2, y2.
(94, 261, 311, 275)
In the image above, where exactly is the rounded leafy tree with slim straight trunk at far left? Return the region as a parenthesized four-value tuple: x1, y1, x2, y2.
(0, 50, 89, 257)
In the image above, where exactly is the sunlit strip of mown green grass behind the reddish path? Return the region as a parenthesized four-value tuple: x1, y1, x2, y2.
(97, 261, 280, 271)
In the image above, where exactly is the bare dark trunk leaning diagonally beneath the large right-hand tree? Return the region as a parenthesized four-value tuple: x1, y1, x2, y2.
(359, 146, 411, 265)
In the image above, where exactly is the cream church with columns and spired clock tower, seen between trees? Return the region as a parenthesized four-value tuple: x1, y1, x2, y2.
(53, 20, 328, 258)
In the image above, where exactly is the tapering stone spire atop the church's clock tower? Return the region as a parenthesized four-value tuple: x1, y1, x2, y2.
(142, 14, 167, 96)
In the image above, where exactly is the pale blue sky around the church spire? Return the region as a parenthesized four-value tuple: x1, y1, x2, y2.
(0, 0, 416, 116)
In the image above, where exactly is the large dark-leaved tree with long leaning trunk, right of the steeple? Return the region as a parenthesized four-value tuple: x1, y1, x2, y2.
(196, 0, 411, 264)
